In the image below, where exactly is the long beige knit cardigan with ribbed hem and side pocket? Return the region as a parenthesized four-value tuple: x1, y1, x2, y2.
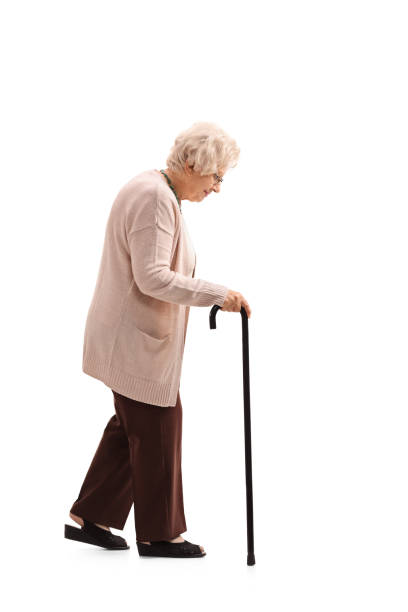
(82, 169, 228, 406)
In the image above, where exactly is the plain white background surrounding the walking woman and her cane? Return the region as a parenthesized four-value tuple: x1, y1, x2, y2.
(0, 0, 408, 612)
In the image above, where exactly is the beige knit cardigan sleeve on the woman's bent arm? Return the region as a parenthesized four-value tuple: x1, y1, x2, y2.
(128, 192, 228, 306)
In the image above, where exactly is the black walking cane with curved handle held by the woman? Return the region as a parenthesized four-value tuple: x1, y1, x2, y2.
(210, 304, 255, 565)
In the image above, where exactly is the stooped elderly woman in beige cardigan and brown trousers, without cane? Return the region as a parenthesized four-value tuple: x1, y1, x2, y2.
(65, 122, 251, 557)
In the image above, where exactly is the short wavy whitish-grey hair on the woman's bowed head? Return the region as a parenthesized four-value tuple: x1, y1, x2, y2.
(166, 121, 240, 176)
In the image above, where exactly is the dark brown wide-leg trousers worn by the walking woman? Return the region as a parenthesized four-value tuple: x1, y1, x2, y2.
(71, 390, 187, 542)
